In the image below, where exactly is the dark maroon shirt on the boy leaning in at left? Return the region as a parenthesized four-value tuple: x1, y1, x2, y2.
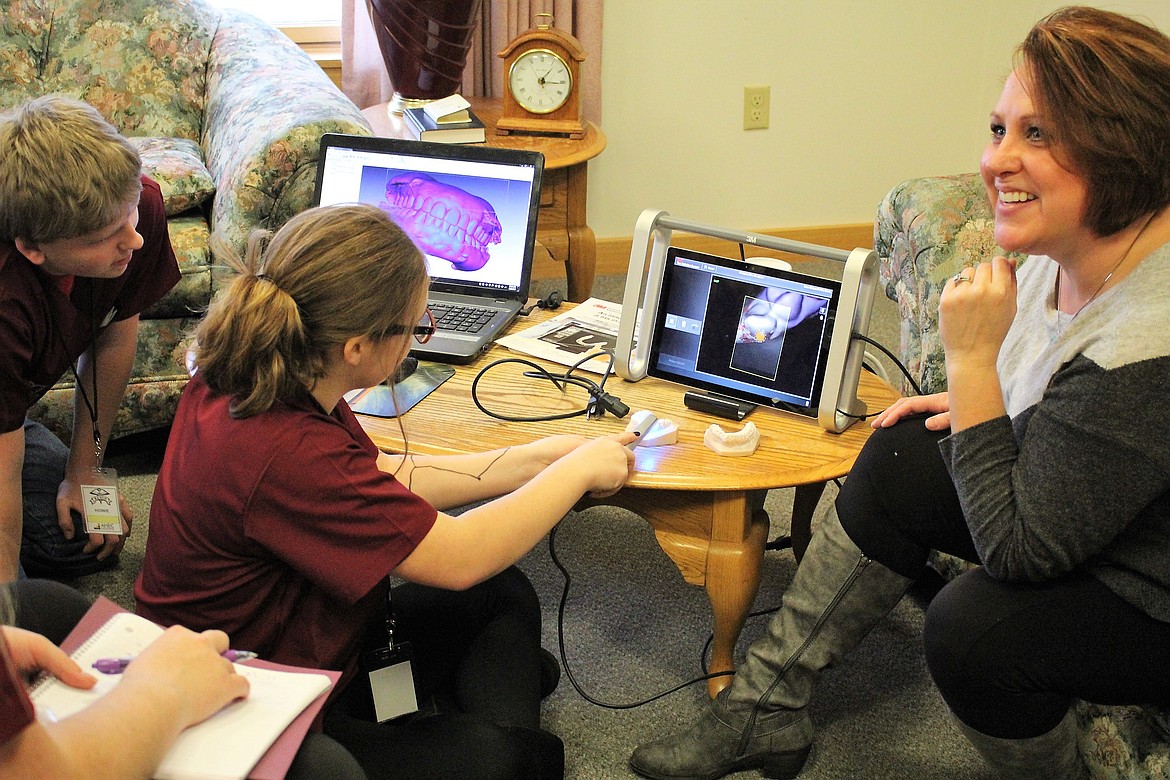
(0, 177, 179, 433)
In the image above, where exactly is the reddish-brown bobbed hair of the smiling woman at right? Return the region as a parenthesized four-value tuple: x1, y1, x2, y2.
(1017, 6, 1170, 236)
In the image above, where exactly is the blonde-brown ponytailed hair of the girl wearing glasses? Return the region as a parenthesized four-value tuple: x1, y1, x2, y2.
(194, 205, 427, 417)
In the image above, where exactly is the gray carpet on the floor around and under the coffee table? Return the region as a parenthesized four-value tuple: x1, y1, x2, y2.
(59, 270, 991, 780)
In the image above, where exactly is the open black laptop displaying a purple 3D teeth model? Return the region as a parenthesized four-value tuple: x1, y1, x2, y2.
(314, 133, 544, 364)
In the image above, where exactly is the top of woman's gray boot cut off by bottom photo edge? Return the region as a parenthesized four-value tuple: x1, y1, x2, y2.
(955, 710, 1089, 780)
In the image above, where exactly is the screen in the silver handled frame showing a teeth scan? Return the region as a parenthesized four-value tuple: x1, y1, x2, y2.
(651, 248, 839, 414)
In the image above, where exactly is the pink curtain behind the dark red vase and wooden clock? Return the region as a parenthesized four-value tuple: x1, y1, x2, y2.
(342, 0, 605, 124)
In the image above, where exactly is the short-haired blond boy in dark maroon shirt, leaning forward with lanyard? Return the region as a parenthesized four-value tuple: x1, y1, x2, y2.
(0, 96, 179, 582)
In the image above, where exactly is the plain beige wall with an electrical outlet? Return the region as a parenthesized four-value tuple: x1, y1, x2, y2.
(589, 0, 1170, 239)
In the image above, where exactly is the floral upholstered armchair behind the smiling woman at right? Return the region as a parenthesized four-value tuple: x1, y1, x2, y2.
(874, 173, 1170, 780)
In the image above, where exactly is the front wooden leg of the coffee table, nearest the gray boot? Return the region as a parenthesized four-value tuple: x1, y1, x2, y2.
(707, 491, 769, 698)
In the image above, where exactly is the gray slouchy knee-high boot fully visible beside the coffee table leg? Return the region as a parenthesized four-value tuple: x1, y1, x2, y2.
(629, 511, 911, 780)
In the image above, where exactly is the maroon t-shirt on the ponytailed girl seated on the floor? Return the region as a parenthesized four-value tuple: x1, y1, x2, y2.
(135, 374, 438, 682)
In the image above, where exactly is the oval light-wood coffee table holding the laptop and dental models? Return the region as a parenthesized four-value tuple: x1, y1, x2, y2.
(358, 310, 897, 696)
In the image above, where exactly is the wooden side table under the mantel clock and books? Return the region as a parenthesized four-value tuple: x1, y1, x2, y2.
(362, 97, 605, 302)
